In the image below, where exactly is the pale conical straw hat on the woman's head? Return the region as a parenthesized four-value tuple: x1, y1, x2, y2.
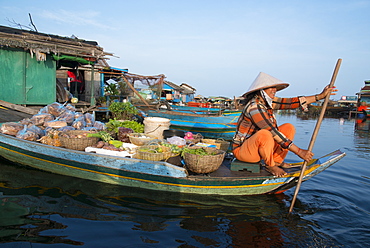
(243, 72, 289, 97)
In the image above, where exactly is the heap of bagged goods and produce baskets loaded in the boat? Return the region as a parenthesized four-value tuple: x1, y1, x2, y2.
(1, 103, 225, 173)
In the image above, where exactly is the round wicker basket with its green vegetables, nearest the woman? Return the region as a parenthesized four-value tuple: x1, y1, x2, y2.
(182, 147, 225, 174)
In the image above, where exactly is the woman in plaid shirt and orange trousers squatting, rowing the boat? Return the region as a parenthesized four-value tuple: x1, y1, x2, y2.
(233, 72, 337, 177)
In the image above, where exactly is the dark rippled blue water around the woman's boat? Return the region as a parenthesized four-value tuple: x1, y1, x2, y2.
(0, 115, 370, 248)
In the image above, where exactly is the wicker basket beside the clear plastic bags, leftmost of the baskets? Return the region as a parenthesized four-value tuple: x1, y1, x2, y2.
(59, 130, 99, 151)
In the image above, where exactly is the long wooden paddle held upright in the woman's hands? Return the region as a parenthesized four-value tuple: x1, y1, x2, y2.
(289, 59, 342, 213)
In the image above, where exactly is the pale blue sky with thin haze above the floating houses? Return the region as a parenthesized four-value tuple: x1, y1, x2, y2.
(0, 0, 370, 99)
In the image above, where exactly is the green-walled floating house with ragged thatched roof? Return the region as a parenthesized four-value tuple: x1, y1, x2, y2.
(0, 26, 113, 105)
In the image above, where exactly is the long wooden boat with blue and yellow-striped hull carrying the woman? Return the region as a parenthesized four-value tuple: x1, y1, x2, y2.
(0, 134, 345, 195)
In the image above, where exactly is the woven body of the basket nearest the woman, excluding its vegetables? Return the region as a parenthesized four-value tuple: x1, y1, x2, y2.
(184, 148, 225, 174)
